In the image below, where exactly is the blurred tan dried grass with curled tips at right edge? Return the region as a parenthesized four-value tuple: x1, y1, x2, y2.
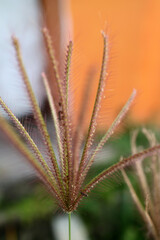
(122, 128, 160, 240)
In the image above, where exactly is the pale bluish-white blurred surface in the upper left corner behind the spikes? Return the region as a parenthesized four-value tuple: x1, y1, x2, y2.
(0, 0, 45, 116)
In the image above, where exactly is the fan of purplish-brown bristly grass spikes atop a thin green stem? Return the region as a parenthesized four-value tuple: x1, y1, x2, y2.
(0, 28, 160, 212)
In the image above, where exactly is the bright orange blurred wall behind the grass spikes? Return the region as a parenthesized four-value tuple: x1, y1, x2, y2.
(71, 0, 160, 125)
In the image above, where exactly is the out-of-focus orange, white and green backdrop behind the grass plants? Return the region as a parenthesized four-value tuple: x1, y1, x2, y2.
(0, 0, 160, 240)
